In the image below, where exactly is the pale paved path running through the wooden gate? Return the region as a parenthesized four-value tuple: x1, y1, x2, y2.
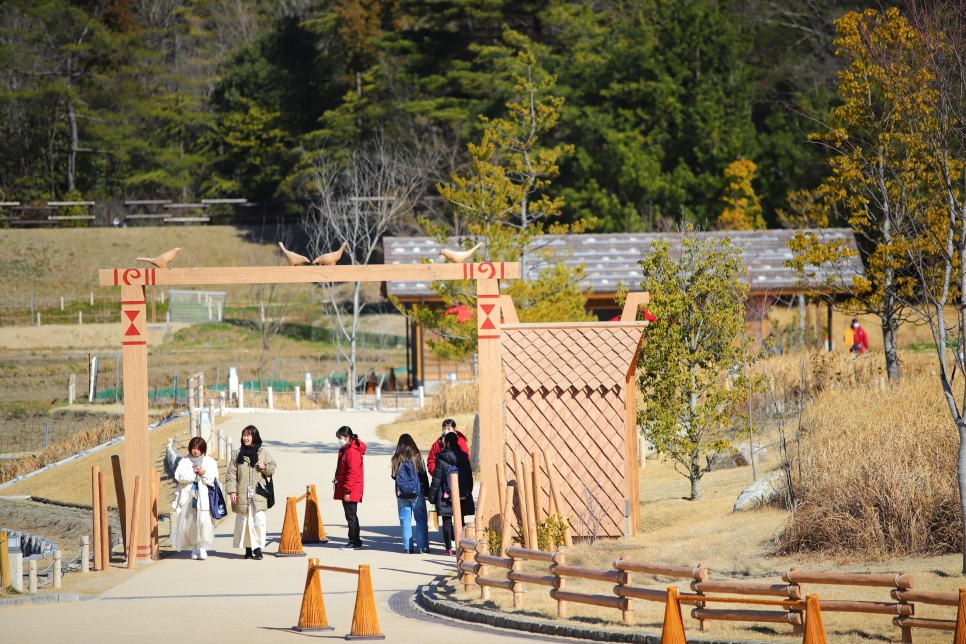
(0, 411, 544, 644)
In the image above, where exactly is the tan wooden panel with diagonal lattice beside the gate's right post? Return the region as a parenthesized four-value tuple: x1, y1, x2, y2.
(502, 294, 647, 537)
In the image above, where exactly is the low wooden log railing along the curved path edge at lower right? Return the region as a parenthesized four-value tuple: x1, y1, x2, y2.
(459, 540, 966, 644)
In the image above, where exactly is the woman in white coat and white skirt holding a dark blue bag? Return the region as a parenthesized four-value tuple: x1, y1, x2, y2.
(171, 436, 218, 559)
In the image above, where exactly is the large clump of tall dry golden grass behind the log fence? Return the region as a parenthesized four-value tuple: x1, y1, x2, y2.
(781, 375, 963, 559)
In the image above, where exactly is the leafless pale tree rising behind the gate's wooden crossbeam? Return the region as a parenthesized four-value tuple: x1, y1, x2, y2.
(306, 137, 436, 407)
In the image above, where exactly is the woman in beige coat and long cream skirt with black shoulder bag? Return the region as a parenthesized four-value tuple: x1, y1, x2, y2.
(225, 425, 275, 559)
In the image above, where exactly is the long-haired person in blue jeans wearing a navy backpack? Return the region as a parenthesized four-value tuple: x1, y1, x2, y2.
(392, 434, 429, 554)
